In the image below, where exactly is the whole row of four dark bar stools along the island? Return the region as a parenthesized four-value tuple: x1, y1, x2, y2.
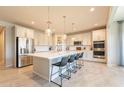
(50, 52, 84, 87)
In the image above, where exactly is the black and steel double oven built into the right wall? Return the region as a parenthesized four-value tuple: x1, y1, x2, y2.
(93, 41, 105, 59)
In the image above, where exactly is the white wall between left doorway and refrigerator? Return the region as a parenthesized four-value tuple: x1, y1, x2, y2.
(0, 21, 15, 67)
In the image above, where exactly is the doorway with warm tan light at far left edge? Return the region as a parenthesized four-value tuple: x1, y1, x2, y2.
(0, 26, 5, 69)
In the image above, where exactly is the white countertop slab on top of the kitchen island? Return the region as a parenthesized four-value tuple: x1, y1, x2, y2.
(28, 51, 84, 59)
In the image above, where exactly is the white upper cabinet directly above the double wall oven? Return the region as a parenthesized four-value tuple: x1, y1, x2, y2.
(92, 29, 105, 41)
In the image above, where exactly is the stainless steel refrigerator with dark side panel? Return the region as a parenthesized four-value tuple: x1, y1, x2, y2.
(16, 37, 34, 67)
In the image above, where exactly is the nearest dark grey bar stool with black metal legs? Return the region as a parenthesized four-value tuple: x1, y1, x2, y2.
(50, 56, 70, 87)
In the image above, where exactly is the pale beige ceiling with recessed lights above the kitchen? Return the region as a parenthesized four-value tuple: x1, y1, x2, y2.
(0, 6, 110, 33)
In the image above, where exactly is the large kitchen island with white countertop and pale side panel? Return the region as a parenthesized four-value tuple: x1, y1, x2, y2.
(29, 51, 83, 82)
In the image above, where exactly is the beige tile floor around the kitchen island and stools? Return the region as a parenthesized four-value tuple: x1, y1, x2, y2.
(0, 62, 124, 87)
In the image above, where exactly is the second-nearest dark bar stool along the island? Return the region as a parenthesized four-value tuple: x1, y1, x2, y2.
(68, 55, 77, 77)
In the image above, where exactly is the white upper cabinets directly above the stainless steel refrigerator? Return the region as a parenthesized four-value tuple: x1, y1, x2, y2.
(15, 25, 34, 38)
